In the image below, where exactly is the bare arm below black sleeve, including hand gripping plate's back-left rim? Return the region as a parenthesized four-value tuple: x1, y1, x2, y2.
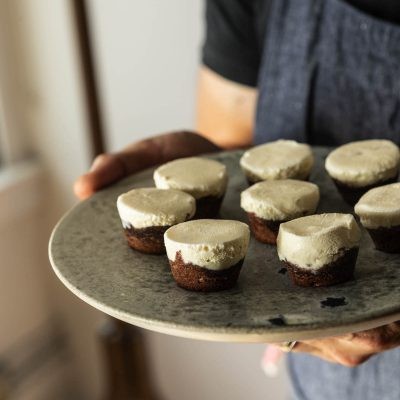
(74, 68, 256, 199)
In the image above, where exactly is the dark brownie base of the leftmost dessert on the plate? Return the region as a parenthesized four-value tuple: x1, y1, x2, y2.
(124, 226, 170, 254)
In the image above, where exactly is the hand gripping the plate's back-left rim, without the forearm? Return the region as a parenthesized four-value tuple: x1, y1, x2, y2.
(74, 131, 221, 200)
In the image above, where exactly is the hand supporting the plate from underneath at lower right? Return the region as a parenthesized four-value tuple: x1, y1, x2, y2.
(292, 321, 400, 367)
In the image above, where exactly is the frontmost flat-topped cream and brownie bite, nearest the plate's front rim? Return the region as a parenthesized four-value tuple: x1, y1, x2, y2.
(164, 219, 250, 292)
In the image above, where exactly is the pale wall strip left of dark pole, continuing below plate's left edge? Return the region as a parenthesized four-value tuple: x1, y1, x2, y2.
(18, 0, 109, 399)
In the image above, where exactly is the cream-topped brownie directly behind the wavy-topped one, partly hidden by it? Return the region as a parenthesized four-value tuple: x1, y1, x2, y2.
(241, 179, 319, 244)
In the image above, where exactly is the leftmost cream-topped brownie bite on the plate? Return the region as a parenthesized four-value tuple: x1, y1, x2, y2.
(117, 188, 196, 254)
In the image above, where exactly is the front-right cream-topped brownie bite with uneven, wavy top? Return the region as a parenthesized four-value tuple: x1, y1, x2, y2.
(277, 213, 360, 286)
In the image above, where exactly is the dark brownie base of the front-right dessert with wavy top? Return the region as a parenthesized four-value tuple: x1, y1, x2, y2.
(284, 247, 358, 287)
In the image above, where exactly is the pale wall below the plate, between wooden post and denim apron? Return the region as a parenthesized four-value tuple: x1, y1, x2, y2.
(147, 333, 287, 400)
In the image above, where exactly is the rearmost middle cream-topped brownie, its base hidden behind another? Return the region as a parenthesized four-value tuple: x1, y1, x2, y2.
(240, 140, 314, 185)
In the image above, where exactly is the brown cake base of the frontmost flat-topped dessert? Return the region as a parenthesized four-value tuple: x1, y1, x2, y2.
(169, 251, 243, 292)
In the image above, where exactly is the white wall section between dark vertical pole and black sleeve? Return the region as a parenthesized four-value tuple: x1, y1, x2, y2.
(88, 0, 203, 150)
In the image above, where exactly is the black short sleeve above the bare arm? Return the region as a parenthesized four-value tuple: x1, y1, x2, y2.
(202, 0, 261, 86)
